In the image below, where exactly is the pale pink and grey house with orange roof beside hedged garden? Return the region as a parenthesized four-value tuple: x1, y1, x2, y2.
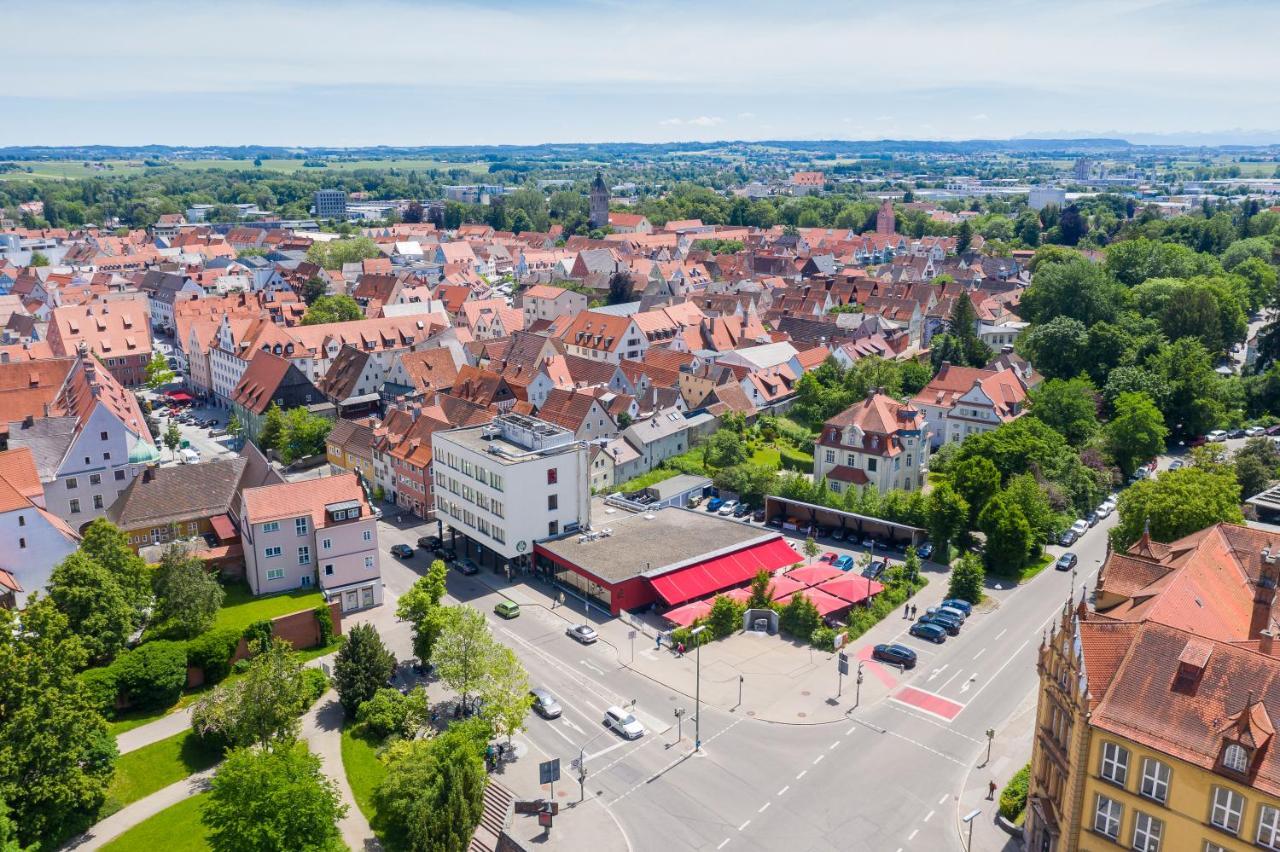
(241, 473, 383, 613)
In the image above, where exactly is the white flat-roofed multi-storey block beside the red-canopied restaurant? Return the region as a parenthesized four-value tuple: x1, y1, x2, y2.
(431, 414, 591, 569)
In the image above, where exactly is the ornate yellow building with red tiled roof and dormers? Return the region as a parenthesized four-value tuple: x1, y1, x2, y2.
(1024, 525, 1280, 852)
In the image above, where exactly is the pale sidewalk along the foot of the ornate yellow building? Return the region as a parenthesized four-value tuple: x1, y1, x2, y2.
(955, 691, 1039, 852)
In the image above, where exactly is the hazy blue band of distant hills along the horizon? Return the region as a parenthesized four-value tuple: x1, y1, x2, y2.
(0, 130, 1280, 161)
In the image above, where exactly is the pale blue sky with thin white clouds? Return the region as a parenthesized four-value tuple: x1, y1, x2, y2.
(10, 0, 1280, 146)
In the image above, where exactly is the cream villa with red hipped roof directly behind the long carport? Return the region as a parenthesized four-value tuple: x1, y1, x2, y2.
(813, 390, 929, 494)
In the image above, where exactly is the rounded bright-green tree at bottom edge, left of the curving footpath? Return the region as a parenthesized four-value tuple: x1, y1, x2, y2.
(201, 747, 347, 852)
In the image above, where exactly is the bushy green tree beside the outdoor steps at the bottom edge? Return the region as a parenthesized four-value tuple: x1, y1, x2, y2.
(374, 720, 489, 852)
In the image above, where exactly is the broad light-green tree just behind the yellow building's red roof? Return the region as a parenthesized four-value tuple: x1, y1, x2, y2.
(1111, 467, 1244, 550)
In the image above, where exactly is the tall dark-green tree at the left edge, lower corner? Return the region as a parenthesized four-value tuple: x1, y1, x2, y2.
(0, 595, 116, 844)
